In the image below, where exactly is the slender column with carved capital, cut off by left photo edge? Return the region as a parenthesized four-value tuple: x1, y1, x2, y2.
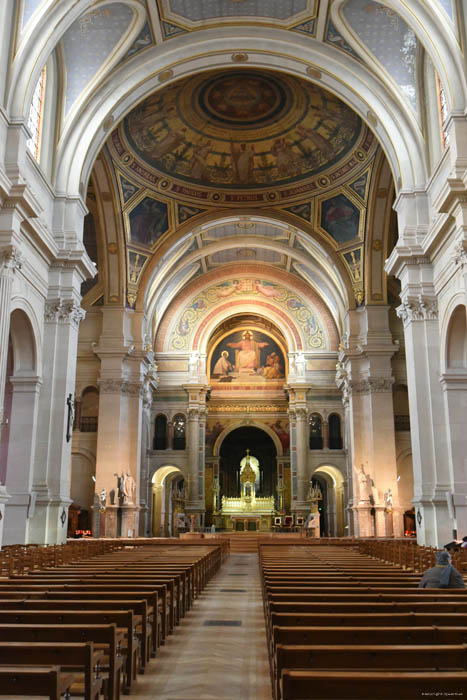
(0, 245, 22, 439)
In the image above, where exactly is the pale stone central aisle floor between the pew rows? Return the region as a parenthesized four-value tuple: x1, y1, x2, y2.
(132, 554, 271, 700)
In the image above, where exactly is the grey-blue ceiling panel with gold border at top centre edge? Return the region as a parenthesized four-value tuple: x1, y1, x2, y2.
(157, 0, 318, 31)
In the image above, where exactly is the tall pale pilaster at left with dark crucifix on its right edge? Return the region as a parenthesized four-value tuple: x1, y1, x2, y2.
(28, 299, 85, 544)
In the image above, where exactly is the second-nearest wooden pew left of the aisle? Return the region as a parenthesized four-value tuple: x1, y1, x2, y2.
(0, 642, 104, 700)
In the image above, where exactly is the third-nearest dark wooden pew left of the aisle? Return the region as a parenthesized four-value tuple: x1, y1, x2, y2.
(0, 624, 125, 700)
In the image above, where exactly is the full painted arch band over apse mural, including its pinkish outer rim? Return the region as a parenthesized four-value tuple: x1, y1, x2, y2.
(165, 276, 329, 351)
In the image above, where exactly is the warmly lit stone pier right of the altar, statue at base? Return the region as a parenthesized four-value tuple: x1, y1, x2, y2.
(336, 305, 403, 537)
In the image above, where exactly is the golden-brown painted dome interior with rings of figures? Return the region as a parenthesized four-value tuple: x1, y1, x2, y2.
(112, 70, 372, 193)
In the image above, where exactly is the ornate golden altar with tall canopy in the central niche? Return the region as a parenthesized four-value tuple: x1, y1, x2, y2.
(215, 450, 276, 532)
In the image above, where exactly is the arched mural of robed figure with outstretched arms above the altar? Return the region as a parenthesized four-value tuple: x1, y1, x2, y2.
(210, 328, 285, 385)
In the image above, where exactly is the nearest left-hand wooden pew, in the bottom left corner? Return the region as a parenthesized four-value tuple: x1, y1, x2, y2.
(0, 665, 75, 700)
